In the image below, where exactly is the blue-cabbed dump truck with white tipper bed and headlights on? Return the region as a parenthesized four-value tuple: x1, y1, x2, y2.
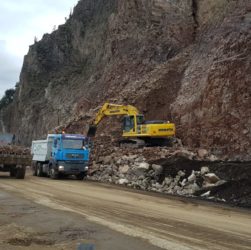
(31, 134, 89, 180)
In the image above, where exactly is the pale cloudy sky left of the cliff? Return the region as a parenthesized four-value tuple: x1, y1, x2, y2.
(0, 0, 78, 97)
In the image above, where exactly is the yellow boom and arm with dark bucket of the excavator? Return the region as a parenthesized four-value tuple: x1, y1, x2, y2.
(87, 103, 139, 137)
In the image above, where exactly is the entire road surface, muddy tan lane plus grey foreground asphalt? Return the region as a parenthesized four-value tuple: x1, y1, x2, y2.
(0, 172, 251, 250)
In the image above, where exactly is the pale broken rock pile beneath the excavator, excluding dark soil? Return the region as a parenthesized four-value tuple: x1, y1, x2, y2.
(88, 147, 226, 198)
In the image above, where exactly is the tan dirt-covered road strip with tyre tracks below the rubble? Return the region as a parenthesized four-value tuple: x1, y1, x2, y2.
(0, 176, 251, 250)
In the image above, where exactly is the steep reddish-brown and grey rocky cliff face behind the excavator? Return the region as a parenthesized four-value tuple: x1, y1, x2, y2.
(0, 0, 251, 159)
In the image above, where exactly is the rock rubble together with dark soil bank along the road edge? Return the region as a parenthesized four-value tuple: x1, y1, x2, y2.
(88, 136, 251, 207)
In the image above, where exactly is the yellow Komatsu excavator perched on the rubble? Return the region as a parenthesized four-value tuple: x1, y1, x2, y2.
(87, 103, 175, 146)
